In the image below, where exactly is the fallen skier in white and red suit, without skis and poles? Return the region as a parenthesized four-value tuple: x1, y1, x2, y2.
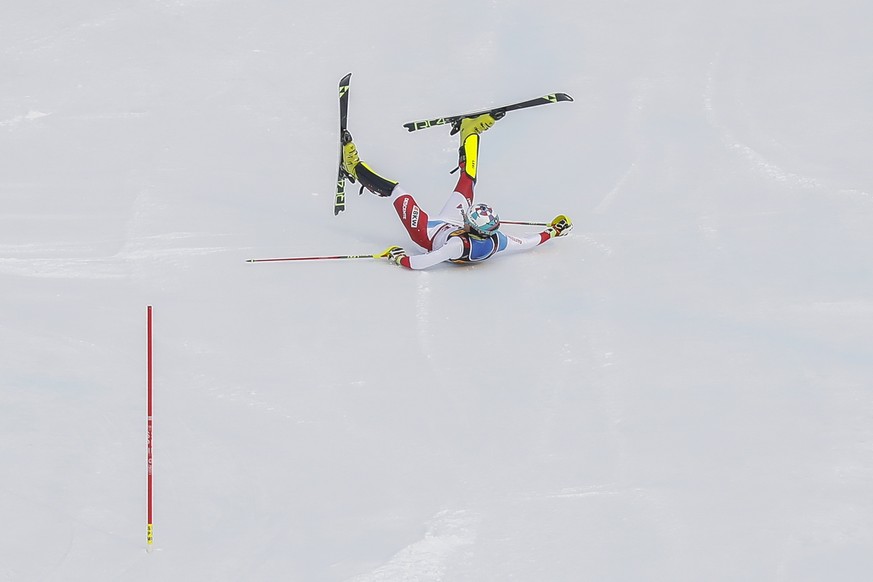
(342, 113, 573, 269)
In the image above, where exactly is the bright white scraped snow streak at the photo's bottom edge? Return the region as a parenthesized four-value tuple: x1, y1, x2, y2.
(349, 509, 481, 582)
